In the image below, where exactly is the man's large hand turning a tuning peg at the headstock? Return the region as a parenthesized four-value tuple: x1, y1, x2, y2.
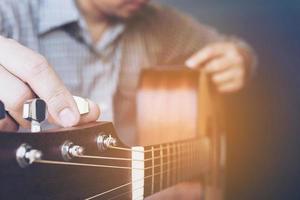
(0, 37, 99, 130)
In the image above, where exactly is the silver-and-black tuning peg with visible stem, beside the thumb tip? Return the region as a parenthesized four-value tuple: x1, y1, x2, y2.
(23, 99, 46, 132)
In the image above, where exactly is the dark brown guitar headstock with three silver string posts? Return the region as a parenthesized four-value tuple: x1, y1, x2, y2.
(0, 98, 132, 199)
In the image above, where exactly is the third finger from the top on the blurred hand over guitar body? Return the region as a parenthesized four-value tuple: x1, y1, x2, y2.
(212, 67, 243, 84)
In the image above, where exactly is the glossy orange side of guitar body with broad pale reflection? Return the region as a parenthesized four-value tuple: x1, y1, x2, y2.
(137, 70, 204, 145)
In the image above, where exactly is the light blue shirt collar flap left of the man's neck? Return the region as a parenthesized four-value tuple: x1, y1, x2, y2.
(38, 0, 80, 35)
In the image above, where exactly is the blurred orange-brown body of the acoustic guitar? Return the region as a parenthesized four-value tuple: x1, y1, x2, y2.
(137, 66, 225, 200)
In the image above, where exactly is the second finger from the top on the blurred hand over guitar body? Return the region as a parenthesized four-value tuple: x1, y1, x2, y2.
(204, 58, 234, 73)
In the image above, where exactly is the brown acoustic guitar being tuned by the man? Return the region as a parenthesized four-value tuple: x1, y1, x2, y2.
(0, 69, 224, 200)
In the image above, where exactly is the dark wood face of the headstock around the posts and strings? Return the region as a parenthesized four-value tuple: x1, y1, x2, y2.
(0, 123, 131, 200)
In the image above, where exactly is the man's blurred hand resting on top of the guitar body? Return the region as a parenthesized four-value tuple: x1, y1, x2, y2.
(186, 42, 249, 93)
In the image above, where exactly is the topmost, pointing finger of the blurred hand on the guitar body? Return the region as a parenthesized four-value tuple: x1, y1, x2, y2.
(185, 46, 220, 69)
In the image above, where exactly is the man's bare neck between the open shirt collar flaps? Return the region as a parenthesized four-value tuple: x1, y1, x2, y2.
(77, 0, 110, 43)
